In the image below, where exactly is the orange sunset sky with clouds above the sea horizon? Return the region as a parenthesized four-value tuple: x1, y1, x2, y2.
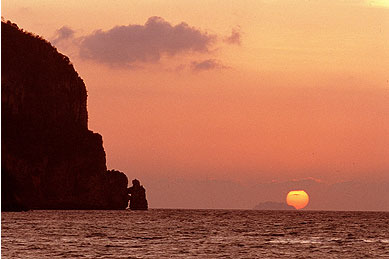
(1, 0, 389, 210)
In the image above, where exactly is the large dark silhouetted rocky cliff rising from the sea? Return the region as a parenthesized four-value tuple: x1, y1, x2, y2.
(1, 22, 129, 210)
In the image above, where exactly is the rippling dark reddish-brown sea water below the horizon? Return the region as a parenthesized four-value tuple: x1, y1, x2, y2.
(1, 209, 389, 258)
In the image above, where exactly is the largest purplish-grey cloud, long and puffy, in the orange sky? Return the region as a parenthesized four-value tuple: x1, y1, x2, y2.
(80, 16, 217, 66)
